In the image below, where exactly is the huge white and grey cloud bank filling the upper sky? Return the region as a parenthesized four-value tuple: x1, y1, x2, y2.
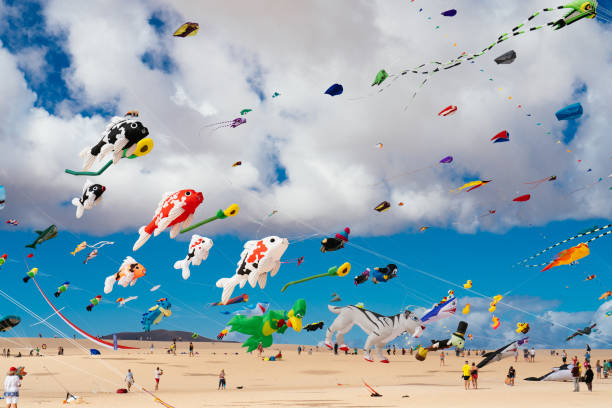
(0, 0, 612, 236)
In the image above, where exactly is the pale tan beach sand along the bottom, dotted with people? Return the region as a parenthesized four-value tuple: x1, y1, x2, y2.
(0, 337, 612, 408)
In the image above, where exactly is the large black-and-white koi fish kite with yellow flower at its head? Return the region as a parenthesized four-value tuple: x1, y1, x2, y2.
(66, 111, 153, 176)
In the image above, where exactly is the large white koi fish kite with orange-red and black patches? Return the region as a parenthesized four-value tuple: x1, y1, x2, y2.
(216, 236, 289, 303)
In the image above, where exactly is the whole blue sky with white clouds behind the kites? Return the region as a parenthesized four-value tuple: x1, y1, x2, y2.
(0, 1, 612, 347)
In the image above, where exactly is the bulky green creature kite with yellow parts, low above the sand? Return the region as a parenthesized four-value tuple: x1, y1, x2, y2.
(228, 299, 306, 353)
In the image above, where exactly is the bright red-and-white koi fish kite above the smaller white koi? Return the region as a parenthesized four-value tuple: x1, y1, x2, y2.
(133, 190, 204, 251)
